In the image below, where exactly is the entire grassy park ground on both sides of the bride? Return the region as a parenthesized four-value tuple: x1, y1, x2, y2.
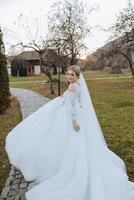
(0, 71, 134, 190)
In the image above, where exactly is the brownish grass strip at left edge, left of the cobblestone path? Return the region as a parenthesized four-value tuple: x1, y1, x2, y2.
(0, 96, 21, 191)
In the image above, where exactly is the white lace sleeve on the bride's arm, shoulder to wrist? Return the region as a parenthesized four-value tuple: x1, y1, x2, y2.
(68, 83, 80, 121)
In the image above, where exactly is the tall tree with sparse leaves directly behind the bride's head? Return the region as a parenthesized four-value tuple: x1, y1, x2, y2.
(48, 0, 93, 64)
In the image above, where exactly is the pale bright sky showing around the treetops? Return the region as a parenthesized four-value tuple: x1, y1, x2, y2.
(0, 0, 127, 56)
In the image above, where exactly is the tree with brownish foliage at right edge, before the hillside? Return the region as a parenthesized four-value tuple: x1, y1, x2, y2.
(111, 0, 134, 79)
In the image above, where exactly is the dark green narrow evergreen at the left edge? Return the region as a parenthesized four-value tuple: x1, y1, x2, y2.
(0, 28, 10, 114)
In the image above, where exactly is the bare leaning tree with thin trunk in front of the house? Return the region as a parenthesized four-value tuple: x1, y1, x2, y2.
(12, 14, 54, 94)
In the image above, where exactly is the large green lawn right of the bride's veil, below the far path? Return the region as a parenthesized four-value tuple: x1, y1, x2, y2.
(88, 80, 134, 181)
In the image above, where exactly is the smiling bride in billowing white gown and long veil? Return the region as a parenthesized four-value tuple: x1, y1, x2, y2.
(6, 65, 134, 200)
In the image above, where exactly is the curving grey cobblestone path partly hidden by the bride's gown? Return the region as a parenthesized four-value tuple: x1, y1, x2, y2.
(0, 88, 50, 200)
